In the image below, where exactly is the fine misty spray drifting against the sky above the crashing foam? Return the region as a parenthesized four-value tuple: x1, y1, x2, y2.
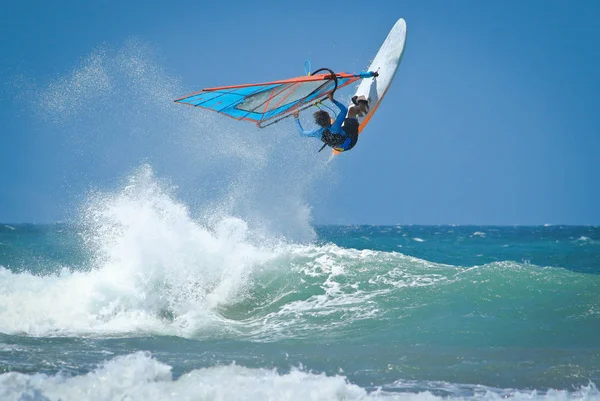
(17, 40, 339, 242)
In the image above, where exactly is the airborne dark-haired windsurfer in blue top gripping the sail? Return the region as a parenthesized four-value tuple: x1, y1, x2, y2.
(294, 93, 369, 152)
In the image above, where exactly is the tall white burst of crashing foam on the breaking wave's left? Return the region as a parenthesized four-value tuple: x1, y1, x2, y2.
(0, 168, 276, 336)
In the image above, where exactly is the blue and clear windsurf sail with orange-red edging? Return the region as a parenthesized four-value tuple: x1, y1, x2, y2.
(175, 68, 377, 128)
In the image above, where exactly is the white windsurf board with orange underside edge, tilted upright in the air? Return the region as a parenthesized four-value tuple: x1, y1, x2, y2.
(342, 18, 406, 142)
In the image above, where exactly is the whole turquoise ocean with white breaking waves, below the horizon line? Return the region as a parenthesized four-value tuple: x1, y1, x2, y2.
(0, 220, 600, 400)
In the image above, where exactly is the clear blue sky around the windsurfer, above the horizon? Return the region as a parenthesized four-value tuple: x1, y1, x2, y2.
(0, 0, 600, 225)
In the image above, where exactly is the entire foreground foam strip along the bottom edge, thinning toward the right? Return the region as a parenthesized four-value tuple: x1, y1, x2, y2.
(0, 352, 600, 401)
